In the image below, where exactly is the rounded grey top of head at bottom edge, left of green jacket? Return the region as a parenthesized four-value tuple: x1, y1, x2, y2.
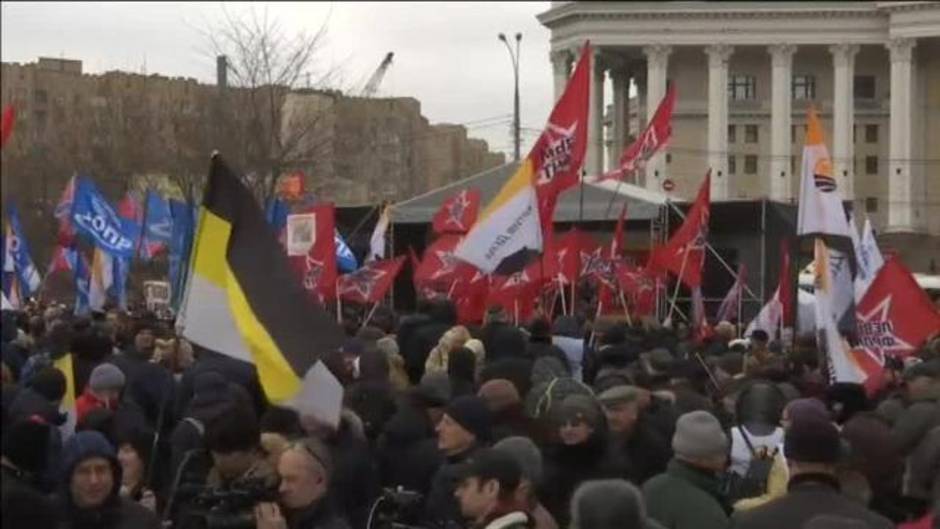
(571, 479, 646, 529)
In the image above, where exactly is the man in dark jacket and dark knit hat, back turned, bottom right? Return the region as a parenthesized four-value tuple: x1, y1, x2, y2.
(732, 414, 894, 529)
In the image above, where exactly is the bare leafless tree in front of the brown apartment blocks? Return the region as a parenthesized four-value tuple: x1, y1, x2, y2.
(206, 10, 336, 203)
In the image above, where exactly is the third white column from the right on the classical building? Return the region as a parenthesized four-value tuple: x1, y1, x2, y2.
(767, 44, 796, 202)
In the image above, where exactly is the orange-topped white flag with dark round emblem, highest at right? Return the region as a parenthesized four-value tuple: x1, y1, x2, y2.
(796, 107, 851, 239)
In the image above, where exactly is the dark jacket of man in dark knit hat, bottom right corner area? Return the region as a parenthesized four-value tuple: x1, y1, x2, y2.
(731, 474, 894, 529)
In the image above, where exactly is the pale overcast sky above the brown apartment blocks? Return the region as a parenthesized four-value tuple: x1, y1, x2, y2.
(0, 2, 552, 155)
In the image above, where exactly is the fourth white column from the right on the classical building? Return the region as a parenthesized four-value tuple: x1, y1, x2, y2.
(705, 44, 734, 200)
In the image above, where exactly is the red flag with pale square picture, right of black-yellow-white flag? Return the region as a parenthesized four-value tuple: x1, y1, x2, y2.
(286, 203, 337, 304)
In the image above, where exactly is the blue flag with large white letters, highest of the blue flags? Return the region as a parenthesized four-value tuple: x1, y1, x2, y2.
(72, 178, 140, 257)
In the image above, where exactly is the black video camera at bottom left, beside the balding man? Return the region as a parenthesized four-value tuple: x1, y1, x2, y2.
(178, 480, 278, 529)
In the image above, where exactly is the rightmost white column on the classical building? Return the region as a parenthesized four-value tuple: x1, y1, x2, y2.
(886, 39, 915, 232)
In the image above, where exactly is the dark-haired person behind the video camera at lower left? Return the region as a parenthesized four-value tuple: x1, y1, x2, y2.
(206, 407, 278, 489)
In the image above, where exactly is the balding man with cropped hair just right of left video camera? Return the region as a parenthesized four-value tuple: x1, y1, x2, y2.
(255, 438, 349, 529)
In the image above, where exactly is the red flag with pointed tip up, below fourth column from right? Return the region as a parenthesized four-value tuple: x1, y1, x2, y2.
(647, 171, 711, 288)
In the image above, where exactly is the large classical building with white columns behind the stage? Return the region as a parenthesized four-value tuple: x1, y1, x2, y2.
(538, 2, 940, 254)
